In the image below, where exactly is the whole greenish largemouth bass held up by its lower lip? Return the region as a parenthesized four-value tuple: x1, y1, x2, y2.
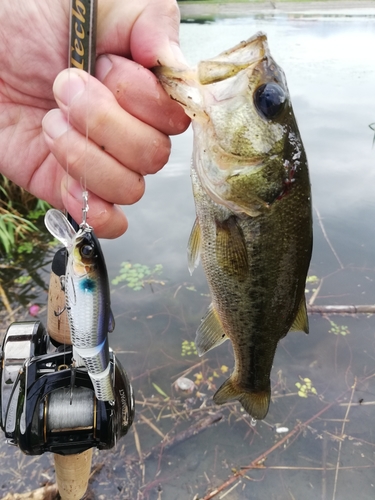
(155, 33, 312, 419)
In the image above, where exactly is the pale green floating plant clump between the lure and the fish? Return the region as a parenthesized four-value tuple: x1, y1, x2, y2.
(111, 262, 165, 291)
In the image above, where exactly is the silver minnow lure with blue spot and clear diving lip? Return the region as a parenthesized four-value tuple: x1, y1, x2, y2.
(44, 209, 114, 401)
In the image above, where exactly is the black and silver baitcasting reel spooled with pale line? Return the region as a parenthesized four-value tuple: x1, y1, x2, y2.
(0, 321, 134, 455)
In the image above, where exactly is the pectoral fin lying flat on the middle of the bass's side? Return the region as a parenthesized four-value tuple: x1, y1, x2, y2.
(216, 216, 248, 278)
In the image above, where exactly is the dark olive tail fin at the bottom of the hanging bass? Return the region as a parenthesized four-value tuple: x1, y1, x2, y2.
(213, 377, 271, 420)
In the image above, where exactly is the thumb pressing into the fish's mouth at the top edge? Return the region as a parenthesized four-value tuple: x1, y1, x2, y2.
(130, 0, 187, 68)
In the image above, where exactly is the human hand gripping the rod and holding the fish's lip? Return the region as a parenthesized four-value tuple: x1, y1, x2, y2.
(0, 0, 189, 238)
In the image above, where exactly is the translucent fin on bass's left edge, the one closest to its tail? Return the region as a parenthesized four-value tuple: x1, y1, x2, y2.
(195, 304, 228, 356)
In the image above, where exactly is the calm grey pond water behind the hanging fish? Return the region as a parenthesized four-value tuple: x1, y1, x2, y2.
(0, 3, 375, 500)
